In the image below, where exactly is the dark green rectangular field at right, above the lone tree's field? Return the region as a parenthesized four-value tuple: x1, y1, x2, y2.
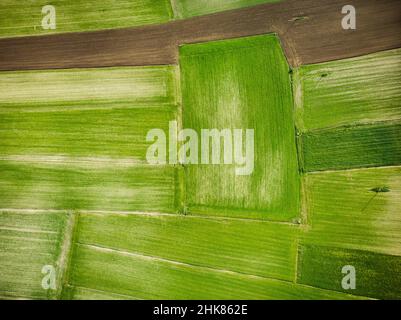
(300, 122, 401, 172)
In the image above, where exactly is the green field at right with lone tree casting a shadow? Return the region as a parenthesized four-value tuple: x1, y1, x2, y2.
(304, 167, 401, 256)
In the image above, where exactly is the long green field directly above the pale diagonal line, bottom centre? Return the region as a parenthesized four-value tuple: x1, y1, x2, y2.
(76, 213, 299, 281)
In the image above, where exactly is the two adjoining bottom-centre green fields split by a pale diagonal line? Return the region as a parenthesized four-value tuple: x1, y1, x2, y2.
(63, 214, 358, 299)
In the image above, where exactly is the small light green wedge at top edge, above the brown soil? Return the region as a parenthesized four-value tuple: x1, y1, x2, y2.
(171, 0, 281, 18)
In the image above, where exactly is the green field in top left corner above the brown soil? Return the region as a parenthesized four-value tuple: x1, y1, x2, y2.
(0, 0, 173, 37)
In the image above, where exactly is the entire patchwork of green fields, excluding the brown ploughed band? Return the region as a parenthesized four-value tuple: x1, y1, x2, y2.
(0, 0, 401, 299)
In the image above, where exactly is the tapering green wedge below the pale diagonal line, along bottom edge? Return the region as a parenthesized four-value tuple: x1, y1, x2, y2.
(64, 244, 366, 300)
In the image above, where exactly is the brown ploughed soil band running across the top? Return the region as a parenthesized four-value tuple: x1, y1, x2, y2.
(0, 0, 401, 70)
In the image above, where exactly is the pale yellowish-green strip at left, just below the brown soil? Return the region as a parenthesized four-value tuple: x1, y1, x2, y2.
(0, 66, 177, 113)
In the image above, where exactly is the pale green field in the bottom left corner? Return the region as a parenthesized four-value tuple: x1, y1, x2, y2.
(0, 210, 72, 299)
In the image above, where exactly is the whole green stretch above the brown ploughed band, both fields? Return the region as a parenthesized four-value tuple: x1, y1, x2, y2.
(0, 0, 281, 38)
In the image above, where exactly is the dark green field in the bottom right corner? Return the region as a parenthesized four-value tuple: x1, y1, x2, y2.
(298, 246, 401, 299)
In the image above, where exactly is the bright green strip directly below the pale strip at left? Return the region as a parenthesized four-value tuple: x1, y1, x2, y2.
(0, 106, 176, 159)
